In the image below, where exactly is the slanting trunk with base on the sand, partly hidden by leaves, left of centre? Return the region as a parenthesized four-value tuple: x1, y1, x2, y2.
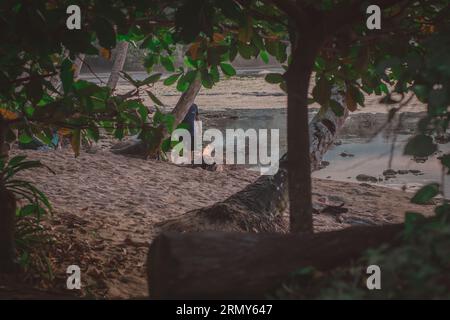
(111, 79, 202, 158)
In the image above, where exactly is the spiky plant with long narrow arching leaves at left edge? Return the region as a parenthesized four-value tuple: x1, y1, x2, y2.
(0, 156, 54, 274)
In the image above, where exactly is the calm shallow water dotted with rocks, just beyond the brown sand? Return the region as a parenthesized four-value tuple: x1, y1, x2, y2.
(203, 109, 450, 198)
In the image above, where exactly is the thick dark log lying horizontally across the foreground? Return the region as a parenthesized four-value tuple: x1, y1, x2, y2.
(148, 224, 403, 299)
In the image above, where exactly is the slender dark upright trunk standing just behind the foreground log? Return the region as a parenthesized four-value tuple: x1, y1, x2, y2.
(286, 32, 322, 232)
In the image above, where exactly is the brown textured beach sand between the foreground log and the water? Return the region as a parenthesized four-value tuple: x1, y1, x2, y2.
(7, 149, 433, 298)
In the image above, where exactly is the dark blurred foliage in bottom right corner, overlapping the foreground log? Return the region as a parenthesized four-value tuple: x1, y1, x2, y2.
(275, 210, 450, 299)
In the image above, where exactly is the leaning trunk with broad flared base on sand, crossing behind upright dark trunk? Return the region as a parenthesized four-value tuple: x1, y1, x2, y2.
(157, 88, 348, 232)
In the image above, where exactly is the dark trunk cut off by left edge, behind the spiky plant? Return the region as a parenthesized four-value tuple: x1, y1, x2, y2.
(0, 116, 16, 272)
